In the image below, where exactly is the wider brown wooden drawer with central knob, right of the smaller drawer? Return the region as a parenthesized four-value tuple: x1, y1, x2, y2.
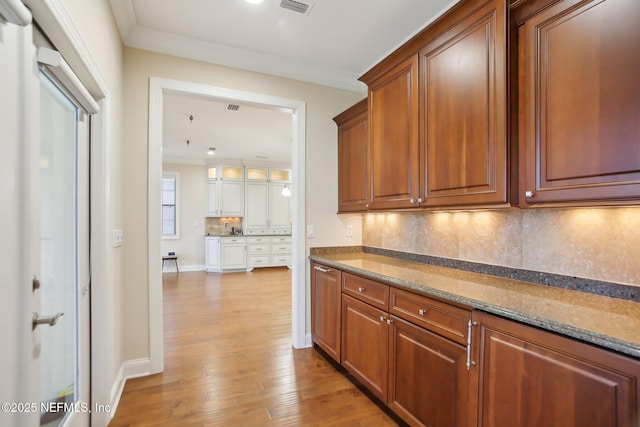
(389, 288, 471, 345)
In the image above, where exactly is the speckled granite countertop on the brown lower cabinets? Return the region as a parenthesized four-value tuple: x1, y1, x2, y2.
(310, 251, 640, 357)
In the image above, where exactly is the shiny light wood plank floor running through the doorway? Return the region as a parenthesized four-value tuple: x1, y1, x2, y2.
(109, 268, 397, 427)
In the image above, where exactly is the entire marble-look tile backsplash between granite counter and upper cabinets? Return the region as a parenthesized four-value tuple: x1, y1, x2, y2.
(362, 207, 640, 287)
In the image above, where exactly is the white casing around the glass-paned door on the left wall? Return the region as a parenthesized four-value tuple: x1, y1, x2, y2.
(20, 0, 114, 425)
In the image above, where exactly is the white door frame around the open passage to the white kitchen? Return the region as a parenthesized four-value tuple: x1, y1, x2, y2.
(148, 77, 308, 373)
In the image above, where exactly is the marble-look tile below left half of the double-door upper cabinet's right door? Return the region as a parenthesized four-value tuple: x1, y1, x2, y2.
(416, 212, 459, 258)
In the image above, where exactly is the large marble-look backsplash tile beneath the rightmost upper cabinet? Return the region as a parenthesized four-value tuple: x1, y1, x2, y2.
(523, 208, 627, 283)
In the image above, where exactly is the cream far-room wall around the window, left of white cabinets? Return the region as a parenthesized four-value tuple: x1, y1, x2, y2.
(161, 163, 206, 271)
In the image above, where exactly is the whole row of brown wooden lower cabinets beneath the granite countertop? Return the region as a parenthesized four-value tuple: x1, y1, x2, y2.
(311, 263, 640, 427)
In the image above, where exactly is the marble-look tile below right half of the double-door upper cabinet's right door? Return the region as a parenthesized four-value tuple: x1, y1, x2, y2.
(455, 209, 522, 267)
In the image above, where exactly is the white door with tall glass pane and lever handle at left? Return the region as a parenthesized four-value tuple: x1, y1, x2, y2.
(34, 70, 90, 427)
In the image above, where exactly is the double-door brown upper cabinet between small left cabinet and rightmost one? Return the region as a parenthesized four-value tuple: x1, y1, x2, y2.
(361, 0, 507, 209)
